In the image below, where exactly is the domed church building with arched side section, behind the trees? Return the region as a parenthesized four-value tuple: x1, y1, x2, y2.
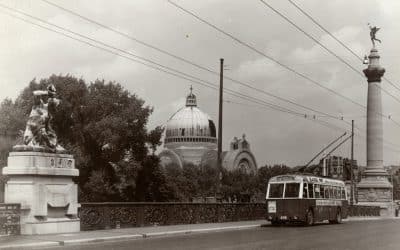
(159, 88, 257, 172)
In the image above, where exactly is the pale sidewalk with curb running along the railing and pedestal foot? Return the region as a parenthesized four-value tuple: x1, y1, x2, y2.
(0, 220, 268, 249)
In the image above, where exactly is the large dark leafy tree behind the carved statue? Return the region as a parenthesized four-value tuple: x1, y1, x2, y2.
(0, 75, 162, 201)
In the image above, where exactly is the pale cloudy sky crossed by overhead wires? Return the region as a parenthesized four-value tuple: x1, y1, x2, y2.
(0, 0, 400, 166)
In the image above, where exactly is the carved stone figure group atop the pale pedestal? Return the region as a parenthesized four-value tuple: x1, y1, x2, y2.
(14, 84, 65, 153)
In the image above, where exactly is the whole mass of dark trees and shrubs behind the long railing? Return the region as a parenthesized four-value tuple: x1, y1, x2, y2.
(0, 75, 290, 202)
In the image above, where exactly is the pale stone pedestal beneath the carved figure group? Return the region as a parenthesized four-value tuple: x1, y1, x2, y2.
(3, 152, 80, 234)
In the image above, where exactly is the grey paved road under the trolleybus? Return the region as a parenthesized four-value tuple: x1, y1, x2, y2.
(42, 220, 400, 250)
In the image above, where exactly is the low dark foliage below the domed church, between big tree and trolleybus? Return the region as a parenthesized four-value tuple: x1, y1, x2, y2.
(164, 164, 291, 202)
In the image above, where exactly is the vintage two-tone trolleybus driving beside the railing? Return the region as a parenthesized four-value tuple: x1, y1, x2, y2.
(266, 175, 348, 225)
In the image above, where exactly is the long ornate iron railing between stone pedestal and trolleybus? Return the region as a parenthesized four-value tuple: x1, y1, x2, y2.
(79, 202, 266, 230)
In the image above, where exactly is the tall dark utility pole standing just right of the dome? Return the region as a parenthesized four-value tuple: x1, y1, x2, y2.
(217, 58, 224, 200)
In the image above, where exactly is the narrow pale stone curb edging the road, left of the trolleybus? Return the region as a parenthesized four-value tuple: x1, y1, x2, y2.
(0, 224, 261, 250)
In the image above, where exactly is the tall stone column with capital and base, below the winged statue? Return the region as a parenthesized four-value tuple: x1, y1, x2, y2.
(358, 46, 393, 214)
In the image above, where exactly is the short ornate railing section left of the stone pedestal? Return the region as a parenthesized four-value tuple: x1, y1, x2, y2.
(0, 203, 21, 235)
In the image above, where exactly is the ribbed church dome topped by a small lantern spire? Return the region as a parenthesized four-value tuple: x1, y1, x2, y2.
(164, 88, 217, 148)
